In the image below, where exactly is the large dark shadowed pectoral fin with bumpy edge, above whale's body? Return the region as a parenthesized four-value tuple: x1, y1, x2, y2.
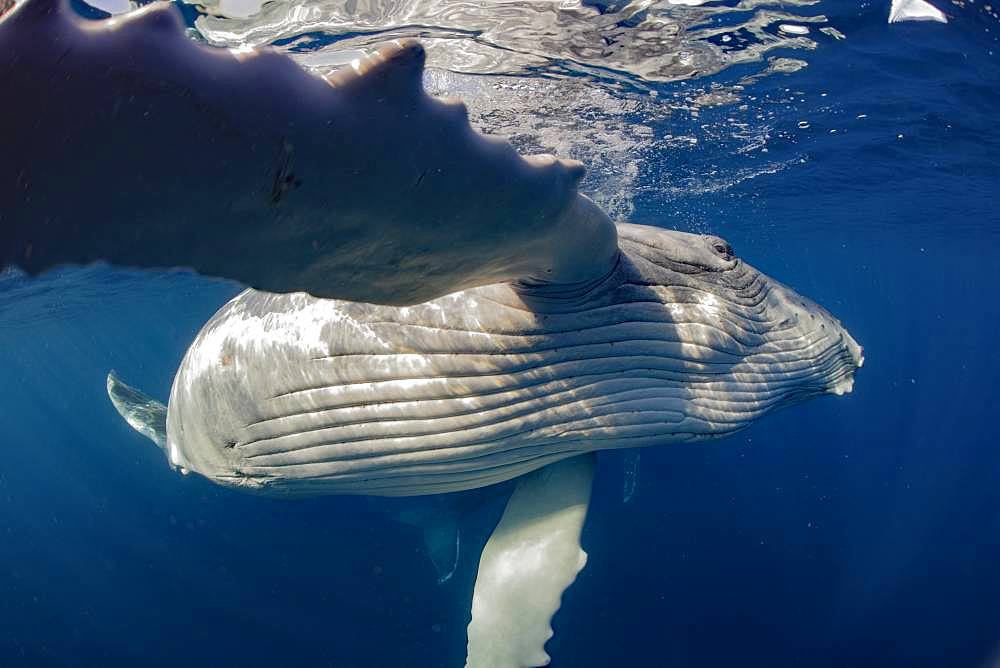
(0, 0, 618, 305)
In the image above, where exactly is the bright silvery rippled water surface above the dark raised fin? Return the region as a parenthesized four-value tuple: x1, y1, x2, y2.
(182, 0, 844, 215)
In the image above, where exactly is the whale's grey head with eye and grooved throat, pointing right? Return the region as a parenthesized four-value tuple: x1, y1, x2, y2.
(615, 225, 864, 437)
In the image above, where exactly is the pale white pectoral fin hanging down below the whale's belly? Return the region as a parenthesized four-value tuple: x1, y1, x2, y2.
(466, 454, 594, 668)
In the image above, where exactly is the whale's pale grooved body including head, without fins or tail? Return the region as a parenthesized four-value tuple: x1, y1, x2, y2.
(167, 225, 861, 495)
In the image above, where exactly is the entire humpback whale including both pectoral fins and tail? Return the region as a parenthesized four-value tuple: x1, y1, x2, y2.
(0, 0, 863, 668)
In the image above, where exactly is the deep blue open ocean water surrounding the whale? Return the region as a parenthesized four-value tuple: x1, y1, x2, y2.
(0, 0, 1000, 668)
